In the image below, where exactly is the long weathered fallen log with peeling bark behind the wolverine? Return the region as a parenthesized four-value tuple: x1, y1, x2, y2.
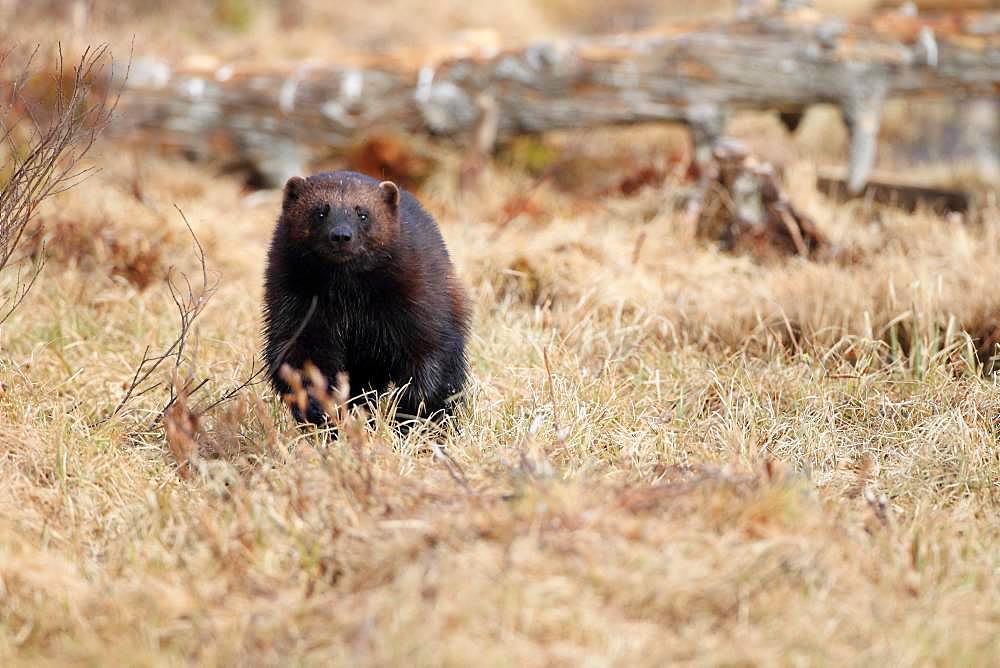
(116, 9, 1000, 192)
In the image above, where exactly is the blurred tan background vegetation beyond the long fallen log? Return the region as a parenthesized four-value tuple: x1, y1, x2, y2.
(0, 0, 1000, 193)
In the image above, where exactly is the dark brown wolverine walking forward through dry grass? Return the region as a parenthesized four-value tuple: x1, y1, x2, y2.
(264, 172, 469, 424)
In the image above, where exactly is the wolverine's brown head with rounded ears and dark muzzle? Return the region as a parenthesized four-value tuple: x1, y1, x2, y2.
(281, 172, 400, 264)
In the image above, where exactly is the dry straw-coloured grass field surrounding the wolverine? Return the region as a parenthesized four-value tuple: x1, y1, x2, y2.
(0, 2, 1000, 666)
